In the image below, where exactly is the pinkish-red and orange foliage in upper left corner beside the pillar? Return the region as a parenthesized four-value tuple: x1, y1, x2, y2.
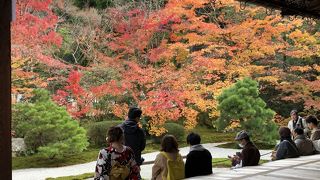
(11, 0, 68, 97)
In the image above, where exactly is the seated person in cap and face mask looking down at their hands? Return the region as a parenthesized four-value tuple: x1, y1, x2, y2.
(228, 130, 260, 168)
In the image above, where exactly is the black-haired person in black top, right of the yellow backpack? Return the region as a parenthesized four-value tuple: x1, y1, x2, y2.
(185, 133, 212, 178)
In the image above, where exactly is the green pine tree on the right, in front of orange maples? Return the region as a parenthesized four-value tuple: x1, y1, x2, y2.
(217, 78, 277, 143)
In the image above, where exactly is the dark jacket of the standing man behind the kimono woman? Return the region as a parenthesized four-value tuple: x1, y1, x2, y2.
(120, 119, 146, 165)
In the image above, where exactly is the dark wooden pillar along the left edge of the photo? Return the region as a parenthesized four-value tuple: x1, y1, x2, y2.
(0, 0, 12, 180)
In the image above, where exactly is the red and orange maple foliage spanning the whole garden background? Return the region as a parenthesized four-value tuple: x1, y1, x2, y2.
(13, 0, 320, 135)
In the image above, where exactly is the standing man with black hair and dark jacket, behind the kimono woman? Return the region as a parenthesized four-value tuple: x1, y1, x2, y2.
(120, 107, 146, 166)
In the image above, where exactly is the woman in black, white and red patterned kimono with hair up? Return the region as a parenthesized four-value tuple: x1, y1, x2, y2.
(94, 127, 140, 180)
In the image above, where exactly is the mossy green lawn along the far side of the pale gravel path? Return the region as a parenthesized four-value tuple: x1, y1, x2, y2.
(12, 127, 235, 169)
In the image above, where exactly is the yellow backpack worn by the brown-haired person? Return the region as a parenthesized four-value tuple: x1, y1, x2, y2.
(161, 152, 184, 180)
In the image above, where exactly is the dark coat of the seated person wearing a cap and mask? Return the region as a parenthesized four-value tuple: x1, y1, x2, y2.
(240, 142, 260, 167)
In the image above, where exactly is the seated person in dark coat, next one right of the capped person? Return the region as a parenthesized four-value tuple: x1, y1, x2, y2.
(273, 127, 300, 160)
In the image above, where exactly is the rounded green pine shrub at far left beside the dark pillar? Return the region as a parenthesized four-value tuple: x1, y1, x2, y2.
(13, 89, 89, 158)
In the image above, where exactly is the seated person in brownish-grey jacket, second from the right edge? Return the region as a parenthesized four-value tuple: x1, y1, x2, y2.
(293, 128, 314, 156)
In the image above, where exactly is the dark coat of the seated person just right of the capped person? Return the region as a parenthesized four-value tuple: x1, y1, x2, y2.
(276, 137, 300, 160)
